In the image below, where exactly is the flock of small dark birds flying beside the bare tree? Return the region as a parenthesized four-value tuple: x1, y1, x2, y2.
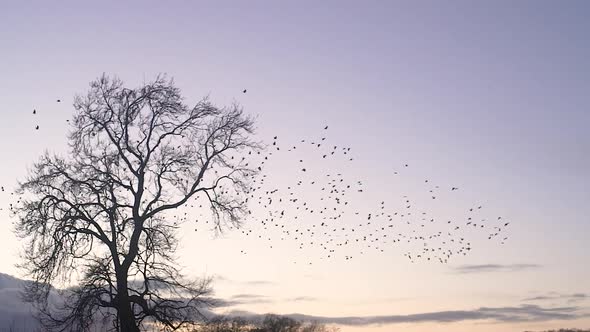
(6, 89, 510, 264)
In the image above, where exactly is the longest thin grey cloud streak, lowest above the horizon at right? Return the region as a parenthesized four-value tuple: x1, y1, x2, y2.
(223, 305, 590, 326)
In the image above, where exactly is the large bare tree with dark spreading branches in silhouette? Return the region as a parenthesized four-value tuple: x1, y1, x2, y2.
(14, 75, 260, 332)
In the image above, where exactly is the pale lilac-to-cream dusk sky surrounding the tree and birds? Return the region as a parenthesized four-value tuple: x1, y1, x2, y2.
(0, 1, 590, 332)
